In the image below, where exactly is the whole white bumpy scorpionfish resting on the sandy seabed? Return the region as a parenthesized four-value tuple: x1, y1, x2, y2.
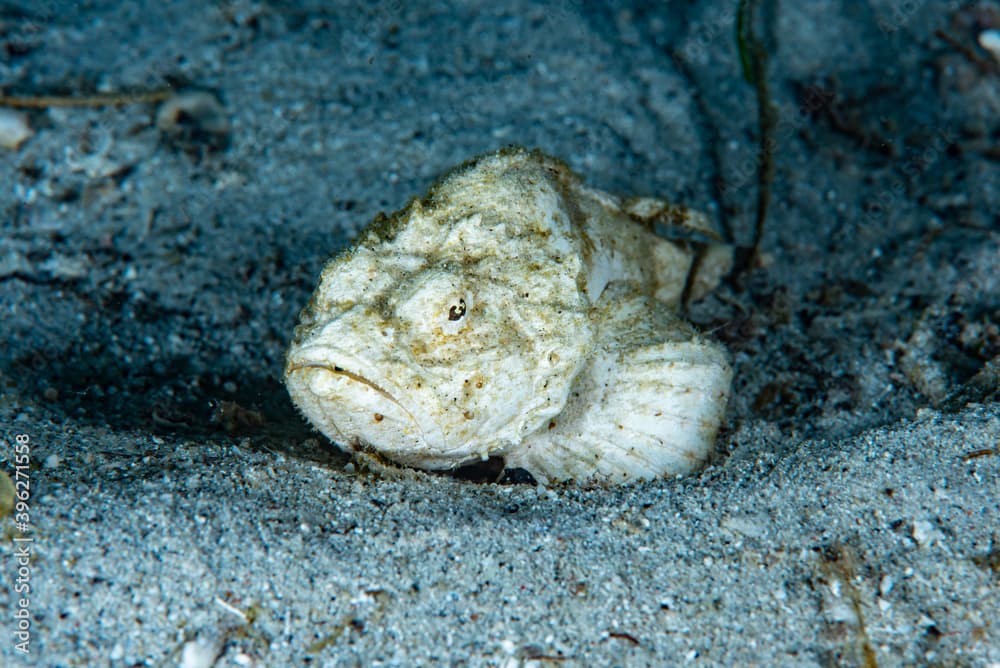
(285, 148, 732, 483)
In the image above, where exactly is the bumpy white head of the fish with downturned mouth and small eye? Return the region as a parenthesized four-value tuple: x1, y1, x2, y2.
(285, 151, 594, 469)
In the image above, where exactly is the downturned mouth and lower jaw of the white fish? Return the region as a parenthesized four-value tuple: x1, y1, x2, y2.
(285, 346, 441, 463)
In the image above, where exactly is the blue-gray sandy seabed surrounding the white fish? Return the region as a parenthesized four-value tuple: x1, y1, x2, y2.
(0, 0, 1000, 668)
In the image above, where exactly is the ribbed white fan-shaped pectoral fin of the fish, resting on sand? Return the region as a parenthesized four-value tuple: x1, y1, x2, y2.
(505, 296, 732, 483)
